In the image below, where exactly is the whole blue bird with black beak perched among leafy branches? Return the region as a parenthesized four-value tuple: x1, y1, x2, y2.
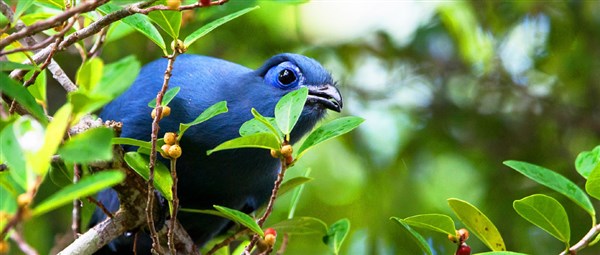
(90, 53, 342, 254)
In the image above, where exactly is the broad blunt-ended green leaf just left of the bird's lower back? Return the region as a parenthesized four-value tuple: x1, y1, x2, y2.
(58, 127, 114, 163)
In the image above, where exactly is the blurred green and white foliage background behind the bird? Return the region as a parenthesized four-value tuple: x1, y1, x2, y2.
(13, 0, 600, 254)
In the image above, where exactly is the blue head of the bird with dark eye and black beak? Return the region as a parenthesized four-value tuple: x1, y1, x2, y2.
(255, 53, 343, 142)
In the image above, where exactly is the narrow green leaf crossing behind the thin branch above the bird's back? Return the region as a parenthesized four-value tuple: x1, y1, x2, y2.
(98, 3, 167, 51)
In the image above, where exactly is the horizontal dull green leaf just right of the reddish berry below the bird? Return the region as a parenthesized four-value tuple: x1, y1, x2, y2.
(270, 217, 327, 236)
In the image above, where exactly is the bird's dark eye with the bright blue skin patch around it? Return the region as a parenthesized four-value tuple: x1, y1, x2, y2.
(265, 61, 304, 89)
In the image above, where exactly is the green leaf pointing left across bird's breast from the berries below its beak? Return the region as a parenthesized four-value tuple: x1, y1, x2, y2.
(206, 133, 280, 155)
